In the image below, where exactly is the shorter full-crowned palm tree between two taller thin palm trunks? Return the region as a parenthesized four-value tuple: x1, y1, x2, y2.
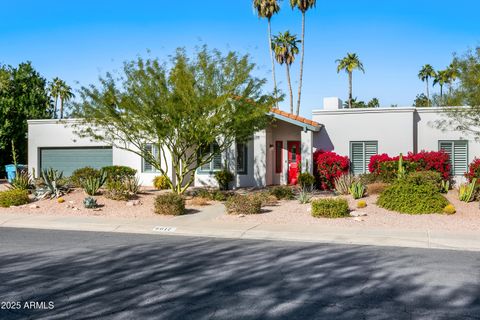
(272, 31, 300, 113)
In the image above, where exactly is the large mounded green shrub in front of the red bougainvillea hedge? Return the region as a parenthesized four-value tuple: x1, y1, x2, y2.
(377, 180, 448, 214)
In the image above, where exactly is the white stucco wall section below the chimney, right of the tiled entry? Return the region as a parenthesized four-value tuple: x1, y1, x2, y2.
(312, 108, 415, 156)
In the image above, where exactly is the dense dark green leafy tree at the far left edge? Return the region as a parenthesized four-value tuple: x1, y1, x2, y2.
(0, 62, 52, 169)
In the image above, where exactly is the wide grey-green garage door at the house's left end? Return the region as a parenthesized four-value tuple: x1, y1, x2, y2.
(40, 148, 113, 176)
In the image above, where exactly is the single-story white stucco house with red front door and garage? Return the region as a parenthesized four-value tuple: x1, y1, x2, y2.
(28, 98, 480, 187)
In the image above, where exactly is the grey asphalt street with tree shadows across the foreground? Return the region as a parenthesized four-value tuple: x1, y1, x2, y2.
(0, 228, 480, 319)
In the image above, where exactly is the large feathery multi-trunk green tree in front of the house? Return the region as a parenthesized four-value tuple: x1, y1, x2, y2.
(77, 47, 275, 193)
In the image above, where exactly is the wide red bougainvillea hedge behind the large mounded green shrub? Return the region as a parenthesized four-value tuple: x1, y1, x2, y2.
(368, 151, 450, 181)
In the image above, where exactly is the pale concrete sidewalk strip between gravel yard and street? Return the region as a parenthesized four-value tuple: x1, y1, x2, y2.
(0, 205, 480, 251)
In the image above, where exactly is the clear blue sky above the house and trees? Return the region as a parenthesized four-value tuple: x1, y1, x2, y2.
(0, 0, 480, 117)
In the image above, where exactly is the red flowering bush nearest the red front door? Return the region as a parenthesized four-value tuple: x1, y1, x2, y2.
(313, 150, 350, 190)
